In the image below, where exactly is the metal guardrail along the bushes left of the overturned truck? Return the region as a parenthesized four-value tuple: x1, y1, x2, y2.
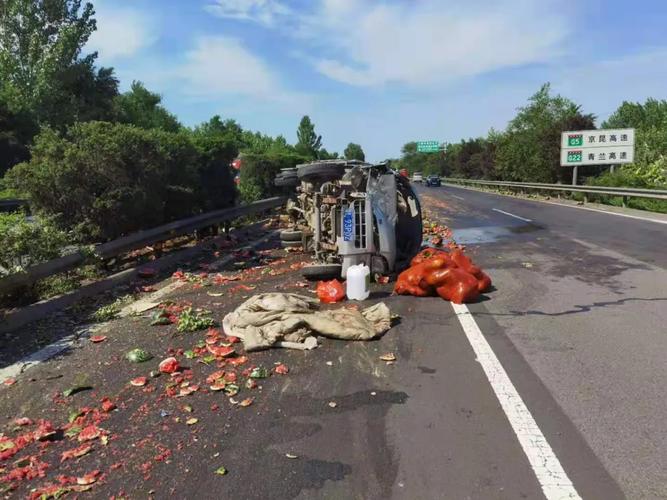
(0, 196, 287, 293)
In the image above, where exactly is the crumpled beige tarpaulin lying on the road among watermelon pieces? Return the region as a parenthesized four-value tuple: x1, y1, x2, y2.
(222, 293, 391, 351)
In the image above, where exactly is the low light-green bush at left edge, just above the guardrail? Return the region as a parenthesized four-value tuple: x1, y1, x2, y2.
(0, 212, 69, 276)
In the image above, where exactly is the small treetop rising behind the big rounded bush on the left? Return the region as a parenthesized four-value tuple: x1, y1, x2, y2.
(115, 81, 181, 132)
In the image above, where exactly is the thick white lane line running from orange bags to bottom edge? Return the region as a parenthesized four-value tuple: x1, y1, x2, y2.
(452, 303, 581, 500)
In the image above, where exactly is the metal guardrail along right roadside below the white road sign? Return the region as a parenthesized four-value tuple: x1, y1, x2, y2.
(443, 178, 667, 202)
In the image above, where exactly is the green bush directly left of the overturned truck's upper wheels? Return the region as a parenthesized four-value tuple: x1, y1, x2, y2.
(239, 153, 307, 203)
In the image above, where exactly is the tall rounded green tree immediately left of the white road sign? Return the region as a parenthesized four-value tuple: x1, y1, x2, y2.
(496, 83, 595, 182)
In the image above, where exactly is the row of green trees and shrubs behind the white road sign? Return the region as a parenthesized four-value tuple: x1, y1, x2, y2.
(394, 84, 667, 212)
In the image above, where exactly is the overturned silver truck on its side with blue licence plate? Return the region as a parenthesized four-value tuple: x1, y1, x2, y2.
(275, 160, 422, 279)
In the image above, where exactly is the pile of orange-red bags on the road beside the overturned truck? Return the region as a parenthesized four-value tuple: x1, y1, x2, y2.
(394, 248, 491, 304)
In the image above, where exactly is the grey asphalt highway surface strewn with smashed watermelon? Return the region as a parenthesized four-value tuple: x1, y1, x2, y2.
(0, 187, 667, 500)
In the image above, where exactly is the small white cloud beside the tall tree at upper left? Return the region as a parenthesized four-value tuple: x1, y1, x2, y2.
(87, 6, 157, 60)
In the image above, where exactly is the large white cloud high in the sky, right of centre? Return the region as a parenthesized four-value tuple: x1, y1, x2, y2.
(311, 0, 567, 86)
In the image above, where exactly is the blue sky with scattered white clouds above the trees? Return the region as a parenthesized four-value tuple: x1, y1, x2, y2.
(88, 0, 667, 160)
